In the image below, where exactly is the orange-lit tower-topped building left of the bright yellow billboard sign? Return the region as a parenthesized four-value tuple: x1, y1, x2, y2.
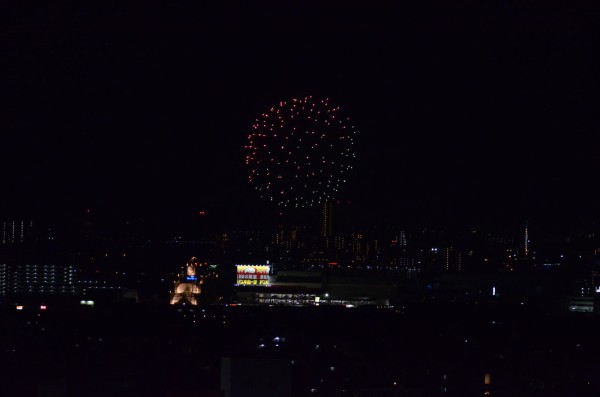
(171, 257, 216, 305)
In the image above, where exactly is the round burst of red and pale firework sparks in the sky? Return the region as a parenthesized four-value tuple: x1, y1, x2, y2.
(245, 96, 355, 208)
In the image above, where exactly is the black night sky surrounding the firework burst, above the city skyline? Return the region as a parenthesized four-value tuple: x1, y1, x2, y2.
(0, 1, 600, 232)
